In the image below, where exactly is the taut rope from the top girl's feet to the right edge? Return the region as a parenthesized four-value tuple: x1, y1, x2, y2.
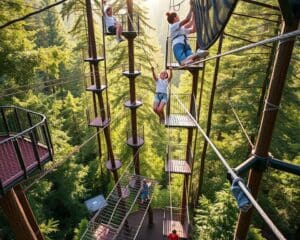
(179, 30, 300, 68)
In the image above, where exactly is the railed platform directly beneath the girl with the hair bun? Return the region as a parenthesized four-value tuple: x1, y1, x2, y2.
(165, 37, 203, 70)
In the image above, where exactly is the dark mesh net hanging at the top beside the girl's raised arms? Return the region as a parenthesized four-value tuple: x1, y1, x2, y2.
(192, 0, 237, 49)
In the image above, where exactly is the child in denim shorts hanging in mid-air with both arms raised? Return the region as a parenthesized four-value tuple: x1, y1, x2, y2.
(151, 67, 172, 124)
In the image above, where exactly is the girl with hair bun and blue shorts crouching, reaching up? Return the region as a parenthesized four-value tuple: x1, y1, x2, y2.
(166, 1, 209, 66)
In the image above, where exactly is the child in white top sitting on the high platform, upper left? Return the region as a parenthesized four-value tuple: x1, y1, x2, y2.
(104, 6, 125, 42)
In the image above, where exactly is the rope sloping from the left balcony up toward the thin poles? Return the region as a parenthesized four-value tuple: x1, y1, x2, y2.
(24, 112, 124, 191)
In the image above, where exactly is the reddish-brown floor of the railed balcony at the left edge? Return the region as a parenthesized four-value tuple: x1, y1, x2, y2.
(0, 136, 51, 189)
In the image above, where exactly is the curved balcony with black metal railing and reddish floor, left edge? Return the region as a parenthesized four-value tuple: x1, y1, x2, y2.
(0, 106, 53, 194)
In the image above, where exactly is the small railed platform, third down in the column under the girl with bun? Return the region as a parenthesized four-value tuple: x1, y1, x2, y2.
(165, 145, 192, 174)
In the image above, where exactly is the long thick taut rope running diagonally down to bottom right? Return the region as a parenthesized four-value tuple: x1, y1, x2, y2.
(173, 93, 286, 240)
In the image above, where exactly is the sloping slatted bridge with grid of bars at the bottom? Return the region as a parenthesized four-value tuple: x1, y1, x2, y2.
(81, 173, 155, 240)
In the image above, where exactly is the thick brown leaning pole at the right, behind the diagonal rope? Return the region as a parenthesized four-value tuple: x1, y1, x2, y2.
(234, 20, 298, 240)
